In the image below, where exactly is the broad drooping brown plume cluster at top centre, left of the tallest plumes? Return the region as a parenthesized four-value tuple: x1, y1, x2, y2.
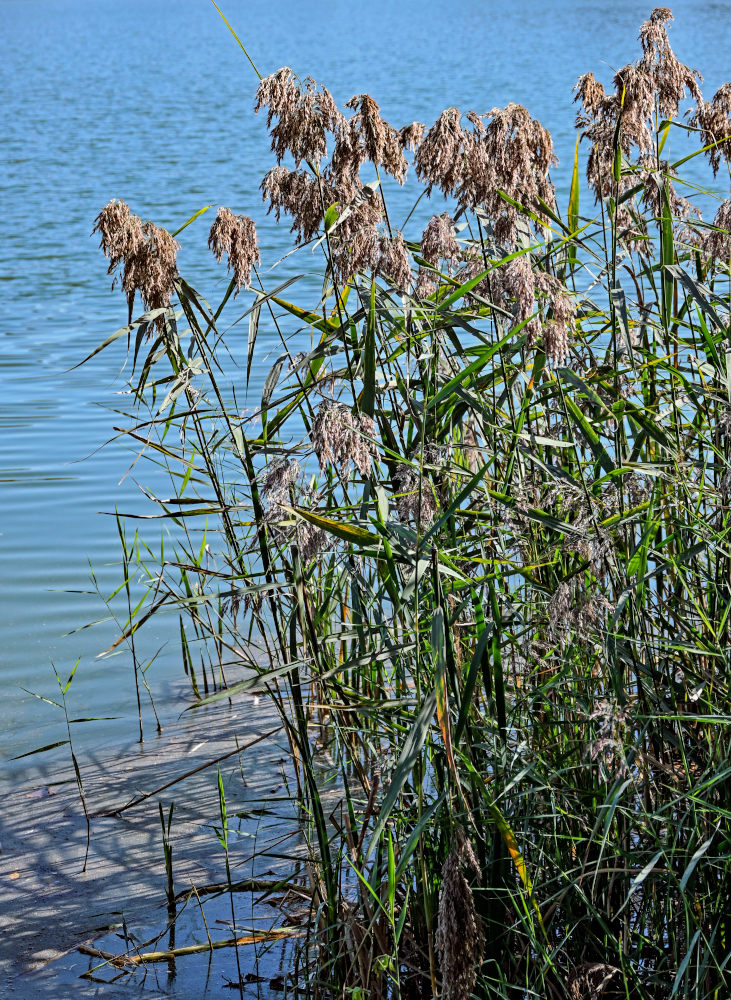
(414, 103, 558, 246)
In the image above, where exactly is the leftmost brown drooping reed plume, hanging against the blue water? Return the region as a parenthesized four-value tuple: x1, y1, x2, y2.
(92, 200, 180, 316)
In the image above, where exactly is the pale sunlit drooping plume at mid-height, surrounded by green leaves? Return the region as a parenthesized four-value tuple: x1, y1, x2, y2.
(310, 399, 377, 477)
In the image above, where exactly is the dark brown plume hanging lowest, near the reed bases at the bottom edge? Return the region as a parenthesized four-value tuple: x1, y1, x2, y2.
(434, 829, 484, 1000)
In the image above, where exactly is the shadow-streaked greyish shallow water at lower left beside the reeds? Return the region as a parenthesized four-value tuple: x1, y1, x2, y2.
(0, 698, 309, 997)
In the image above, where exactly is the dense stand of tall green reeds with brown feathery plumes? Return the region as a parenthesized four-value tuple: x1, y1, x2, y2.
(91, 8, 731, 1000)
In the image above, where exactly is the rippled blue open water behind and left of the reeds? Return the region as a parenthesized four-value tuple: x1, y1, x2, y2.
(0, 0, 731, 774)
